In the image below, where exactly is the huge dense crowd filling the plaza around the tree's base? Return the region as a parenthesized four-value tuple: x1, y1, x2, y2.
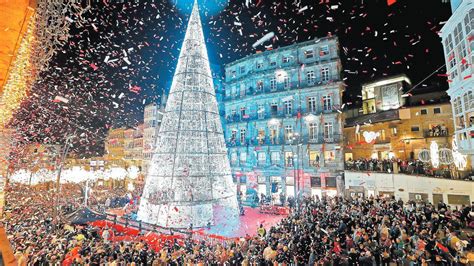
(3, 182, 474, 265)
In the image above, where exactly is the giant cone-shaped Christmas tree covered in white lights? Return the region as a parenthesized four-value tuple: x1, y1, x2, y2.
(138, 1, 238, 228)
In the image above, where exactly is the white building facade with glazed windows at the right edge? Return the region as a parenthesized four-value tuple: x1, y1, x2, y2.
(441, 0, 474, 166)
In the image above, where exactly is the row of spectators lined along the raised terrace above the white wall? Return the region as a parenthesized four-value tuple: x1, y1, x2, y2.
(345, 158, 451, 178)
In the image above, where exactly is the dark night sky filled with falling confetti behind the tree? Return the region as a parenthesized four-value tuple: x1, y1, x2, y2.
(8, 0, 451, 157)
